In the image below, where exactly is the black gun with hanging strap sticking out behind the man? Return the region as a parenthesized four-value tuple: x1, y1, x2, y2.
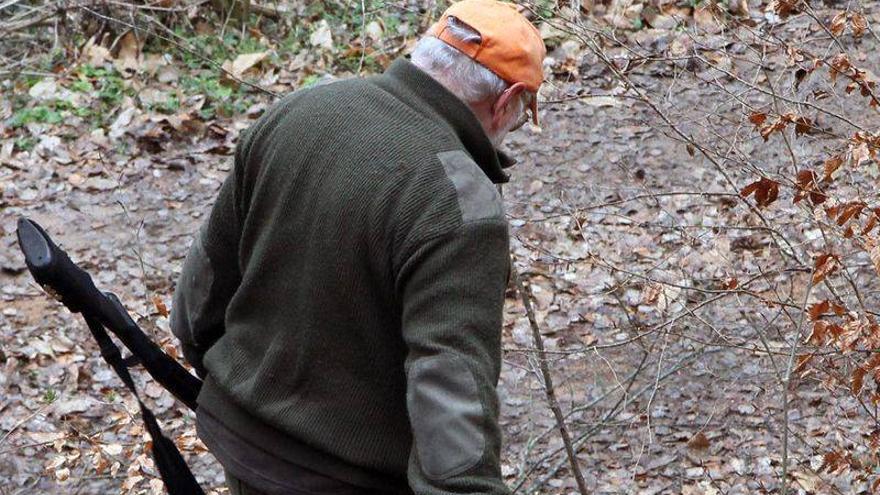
(16, 217, 204, 495)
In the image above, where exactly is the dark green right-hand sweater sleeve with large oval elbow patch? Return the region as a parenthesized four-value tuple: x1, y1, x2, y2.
(398, 217, 510, 495)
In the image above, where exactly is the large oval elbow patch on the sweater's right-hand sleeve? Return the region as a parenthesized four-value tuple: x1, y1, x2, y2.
(406, 355, 486, 480)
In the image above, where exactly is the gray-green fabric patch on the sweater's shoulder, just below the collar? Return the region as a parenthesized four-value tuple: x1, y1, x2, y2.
(437, 150, 504, 223)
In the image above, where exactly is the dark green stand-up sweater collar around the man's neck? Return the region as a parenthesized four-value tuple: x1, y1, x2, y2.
(377, 58, 514, 184)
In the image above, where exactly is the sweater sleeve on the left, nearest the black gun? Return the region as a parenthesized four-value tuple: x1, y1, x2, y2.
(170, 135, 244, 378)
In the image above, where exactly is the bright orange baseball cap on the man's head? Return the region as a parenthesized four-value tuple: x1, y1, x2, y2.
(428, 0, 547, 124)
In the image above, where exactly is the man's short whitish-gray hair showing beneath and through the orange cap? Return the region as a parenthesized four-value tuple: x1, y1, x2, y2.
(410, 17, 531, 111)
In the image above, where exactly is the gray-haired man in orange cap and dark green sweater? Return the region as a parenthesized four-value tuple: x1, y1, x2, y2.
(172, 0, 545, 495)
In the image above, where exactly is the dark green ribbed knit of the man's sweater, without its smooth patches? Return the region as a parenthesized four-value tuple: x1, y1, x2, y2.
(182, 60, 509, 494)
